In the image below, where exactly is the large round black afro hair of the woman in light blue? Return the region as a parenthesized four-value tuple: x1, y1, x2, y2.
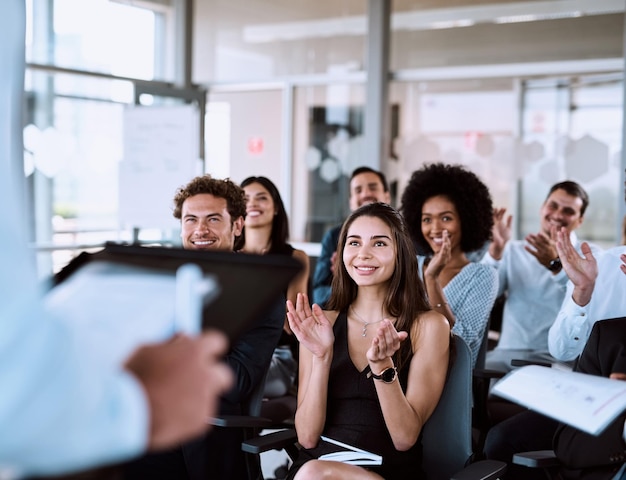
(400, 163, 493, 255)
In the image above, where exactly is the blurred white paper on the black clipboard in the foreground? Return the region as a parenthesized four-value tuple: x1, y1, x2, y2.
(44, 262, 219, 364)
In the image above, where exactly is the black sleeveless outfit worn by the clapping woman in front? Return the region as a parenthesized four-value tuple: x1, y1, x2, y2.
(288, 312, 425, 480)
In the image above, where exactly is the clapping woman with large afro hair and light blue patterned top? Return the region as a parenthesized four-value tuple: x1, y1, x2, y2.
(400, 163, 498, 364)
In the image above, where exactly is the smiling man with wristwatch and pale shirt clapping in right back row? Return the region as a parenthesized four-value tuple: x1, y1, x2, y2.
(482, 181, 589, 371)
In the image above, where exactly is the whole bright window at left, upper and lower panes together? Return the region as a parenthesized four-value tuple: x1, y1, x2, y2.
(24, 0, 173, 275)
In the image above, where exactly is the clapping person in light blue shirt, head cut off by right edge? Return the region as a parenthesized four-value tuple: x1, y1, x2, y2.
(548, 229, 626, 361)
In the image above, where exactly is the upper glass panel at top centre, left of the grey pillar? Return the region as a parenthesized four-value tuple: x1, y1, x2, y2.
(193, 0, 367, 83)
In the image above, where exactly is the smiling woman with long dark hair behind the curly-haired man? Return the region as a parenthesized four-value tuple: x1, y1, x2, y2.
(238, 177, 309, 398)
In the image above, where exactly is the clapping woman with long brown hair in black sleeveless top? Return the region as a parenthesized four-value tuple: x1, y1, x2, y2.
(287, 203, 450, 480)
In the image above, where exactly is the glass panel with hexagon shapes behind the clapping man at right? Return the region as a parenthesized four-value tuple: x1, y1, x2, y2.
(520, 76, 623, 247)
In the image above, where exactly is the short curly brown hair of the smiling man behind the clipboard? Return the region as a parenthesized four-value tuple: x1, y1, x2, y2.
(172, 174, 246, 221)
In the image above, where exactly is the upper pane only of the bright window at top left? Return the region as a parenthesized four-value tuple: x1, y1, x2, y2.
(26, 0, 173, 80)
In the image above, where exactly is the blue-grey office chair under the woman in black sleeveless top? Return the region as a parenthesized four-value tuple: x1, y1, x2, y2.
(242, 335, 506, 480)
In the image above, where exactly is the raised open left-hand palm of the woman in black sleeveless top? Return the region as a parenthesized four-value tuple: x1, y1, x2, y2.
(287, 293, 335, 358)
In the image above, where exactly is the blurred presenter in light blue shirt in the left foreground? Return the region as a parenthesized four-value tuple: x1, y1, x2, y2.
(0, 0, 232, 478)
